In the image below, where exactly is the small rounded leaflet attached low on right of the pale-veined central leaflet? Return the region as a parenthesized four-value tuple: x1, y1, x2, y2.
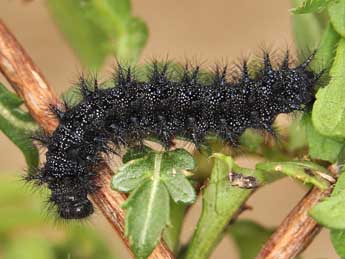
(162, 173, 196, 204)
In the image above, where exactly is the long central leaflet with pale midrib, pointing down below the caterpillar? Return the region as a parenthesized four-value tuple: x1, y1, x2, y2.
(125, 181, 170, 258)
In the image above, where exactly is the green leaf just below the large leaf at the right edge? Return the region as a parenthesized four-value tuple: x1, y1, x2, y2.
(303, 114, 344, 163)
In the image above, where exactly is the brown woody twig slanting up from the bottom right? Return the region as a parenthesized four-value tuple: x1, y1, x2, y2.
(256, 187, 331, 259)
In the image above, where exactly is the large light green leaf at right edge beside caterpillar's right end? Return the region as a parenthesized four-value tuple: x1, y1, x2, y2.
(312, 39, 345, 140)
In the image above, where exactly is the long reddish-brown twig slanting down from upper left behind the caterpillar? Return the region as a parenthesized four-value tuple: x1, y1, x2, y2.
(0, 19, 174, 259)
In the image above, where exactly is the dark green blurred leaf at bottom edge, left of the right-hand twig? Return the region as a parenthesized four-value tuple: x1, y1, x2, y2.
(228, 220, 273, 259)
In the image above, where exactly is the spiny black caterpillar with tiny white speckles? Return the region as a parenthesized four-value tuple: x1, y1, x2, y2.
(29, 54, 320, 219)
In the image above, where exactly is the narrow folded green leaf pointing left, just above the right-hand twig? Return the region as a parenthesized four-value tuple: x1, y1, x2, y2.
(256, 161, 329, 190)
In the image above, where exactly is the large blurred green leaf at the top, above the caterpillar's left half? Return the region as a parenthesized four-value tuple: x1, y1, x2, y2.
(48, 0, 148, 69)
